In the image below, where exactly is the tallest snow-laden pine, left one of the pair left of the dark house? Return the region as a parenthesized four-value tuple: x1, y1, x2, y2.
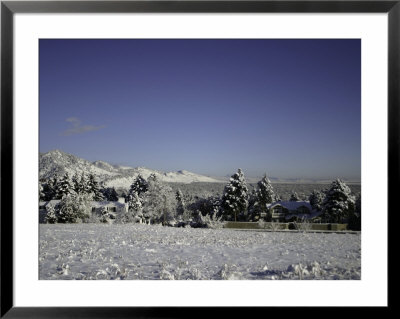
(221, 168, 248, 221)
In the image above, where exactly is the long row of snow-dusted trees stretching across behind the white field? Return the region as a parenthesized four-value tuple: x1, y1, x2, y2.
(39, 169, 361, 230)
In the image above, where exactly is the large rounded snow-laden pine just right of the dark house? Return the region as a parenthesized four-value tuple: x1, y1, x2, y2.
(322, 179, 355, 223)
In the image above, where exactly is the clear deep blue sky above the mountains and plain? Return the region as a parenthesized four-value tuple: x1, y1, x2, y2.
(39, 39, 361, 179)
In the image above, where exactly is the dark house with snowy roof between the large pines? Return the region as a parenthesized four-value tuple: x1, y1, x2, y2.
(267, 201, 320, 222)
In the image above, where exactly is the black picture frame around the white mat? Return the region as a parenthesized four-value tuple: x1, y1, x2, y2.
(0, 0, 394, 318)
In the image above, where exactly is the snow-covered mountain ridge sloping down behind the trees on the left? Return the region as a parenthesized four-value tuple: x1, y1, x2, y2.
(39, 150, 221, 189)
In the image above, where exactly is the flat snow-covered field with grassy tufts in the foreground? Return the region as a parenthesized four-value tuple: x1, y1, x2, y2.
(39, 224, 361, 280)
